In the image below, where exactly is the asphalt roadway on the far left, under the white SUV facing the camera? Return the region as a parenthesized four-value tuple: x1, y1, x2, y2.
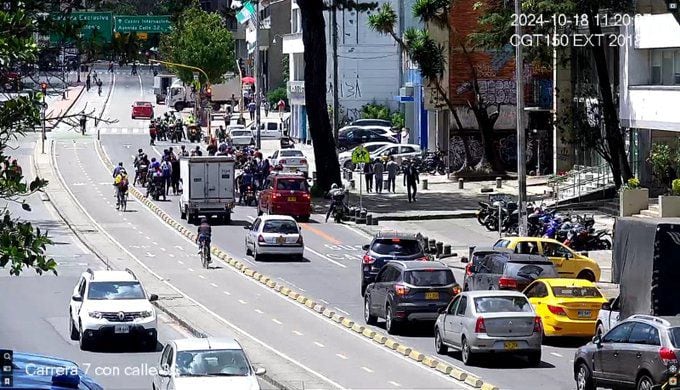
(0, 136, 189, 389)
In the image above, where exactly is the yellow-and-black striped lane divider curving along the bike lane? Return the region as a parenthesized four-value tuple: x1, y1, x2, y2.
(95, 141, 498, 390)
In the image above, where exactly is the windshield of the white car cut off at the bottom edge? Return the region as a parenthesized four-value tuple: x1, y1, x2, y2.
(175, 349, 250, 376)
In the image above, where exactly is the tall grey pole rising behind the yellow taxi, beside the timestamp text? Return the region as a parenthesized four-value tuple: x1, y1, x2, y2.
(515, 0, 527, 236)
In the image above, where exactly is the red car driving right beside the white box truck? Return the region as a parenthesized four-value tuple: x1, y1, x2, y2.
(257, 173, 312, 222)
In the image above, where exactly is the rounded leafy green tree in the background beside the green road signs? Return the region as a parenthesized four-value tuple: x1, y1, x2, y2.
(161, 7, 236, 84)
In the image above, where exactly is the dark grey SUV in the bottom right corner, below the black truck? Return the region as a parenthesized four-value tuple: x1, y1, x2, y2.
(574, 314, 680, 390)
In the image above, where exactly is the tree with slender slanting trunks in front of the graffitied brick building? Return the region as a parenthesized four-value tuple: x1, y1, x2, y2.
(369, 0, 504, 172)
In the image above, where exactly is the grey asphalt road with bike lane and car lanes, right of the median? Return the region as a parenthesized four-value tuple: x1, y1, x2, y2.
(51, 65, 583, 389)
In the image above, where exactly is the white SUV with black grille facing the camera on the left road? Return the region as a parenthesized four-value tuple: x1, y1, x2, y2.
(69, 268, 158, 351)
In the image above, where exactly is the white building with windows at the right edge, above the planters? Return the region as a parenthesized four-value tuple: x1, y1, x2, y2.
(619, 10, 680, 186)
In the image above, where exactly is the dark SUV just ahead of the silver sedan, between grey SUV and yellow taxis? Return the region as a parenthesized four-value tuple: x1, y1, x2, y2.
(466, 253, 559, 291)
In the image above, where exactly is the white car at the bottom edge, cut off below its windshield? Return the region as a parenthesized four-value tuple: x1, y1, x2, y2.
(153, 337, 265, 390)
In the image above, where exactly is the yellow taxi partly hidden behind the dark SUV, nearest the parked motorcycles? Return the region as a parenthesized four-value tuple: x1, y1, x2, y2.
(494, 237, 600, 282)
